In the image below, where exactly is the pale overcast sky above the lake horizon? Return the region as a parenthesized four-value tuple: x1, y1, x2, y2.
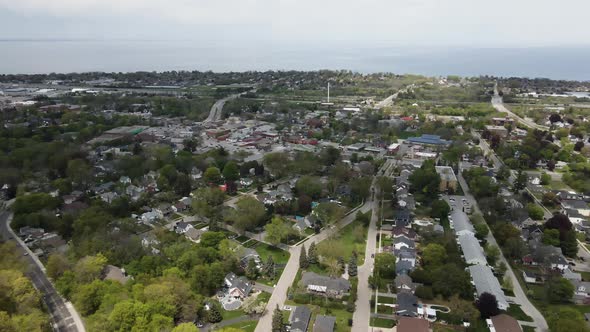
(0, 0, 590, 47)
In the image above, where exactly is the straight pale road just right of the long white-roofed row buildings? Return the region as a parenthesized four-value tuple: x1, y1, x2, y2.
(457, 172, 549, 332)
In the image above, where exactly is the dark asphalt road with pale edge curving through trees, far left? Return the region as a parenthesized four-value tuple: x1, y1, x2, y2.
(0, 211, 86, 332)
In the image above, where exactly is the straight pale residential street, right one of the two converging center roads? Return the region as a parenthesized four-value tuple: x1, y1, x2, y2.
(352, 191, 379, 332)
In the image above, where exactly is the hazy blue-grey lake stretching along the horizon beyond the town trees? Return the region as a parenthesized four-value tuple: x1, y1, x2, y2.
(0, 41, 590, 80)
